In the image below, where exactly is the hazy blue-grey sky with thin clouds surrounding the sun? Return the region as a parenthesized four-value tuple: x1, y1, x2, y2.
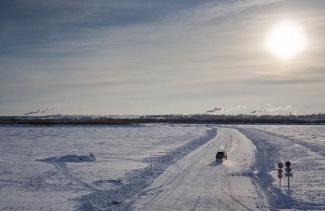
(0, 0, 325, 116)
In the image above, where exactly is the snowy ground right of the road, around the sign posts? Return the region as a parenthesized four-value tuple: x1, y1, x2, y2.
(235, 125, 325, 210)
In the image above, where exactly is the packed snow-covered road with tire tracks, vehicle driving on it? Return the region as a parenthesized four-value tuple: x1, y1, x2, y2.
(133, 128, 266, 210)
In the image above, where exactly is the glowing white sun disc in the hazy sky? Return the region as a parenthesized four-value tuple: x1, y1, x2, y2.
(266, 21, 306, 60)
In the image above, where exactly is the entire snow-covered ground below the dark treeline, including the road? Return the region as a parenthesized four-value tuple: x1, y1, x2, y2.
(0, 124, 325, 210)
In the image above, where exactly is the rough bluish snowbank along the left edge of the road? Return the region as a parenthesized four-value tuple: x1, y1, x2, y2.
(79, 127, 217, 210)
